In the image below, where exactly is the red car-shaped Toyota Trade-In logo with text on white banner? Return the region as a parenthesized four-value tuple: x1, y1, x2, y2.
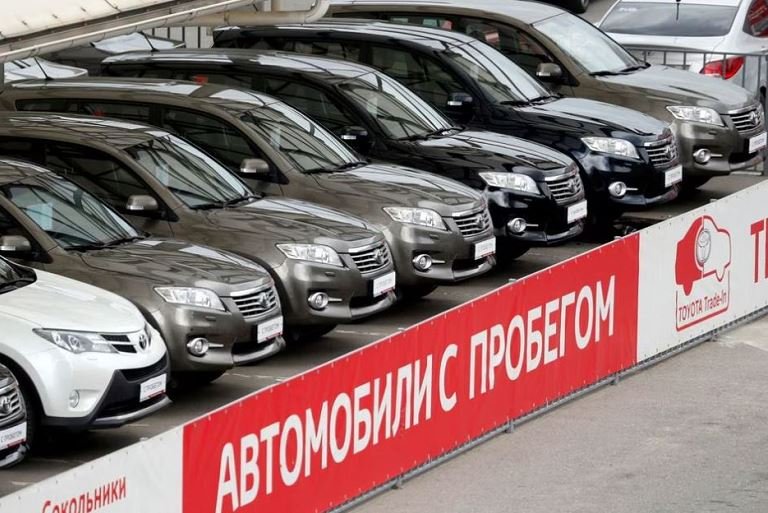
(675, 215, 731, 331)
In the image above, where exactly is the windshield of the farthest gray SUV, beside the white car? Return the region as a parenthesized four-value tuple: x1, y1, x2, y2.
(534, 13, 640, 73)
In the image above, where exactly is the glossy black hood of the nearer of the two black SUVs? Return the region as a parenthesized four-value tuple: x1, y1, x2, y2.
(412, 130, 573, 178)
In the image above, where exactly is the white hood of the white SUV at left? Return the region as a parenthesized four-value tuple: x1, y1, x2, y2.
(0, 271, 145, 333)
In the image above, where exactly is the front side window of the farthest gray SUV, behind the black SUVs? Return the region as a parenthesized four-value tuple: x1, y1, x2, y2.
(458, 18, 553, 75)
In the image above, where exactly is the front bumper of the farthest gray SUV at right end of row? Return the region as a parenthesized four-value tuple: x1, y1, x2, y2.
(672, 116, 765, 177)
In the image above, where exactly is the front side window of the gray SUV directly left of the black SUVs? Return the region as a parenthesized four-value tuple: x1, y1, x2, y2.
(161, 108, 264, 172)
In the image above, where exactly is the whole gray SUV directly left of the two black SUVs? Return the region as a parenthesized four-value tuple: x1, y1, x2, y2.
(0, 79, 496, 297)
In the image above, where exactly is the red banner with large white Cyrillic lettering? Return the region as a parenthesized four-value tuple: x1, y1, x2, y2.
(183, 236, 639, 513)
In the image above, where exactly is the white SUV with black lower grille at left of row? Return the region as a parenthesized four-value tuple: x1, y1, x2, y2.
(0, 259, 170, 442)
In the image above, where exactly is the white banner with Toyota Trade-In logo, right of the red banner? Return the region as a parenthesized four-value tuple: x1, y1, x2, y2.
(637, 182, 768, 362)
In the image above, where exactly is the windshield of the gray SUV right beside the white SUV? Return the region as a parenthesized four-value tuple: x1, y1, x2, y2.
(2, 174, 142, 249)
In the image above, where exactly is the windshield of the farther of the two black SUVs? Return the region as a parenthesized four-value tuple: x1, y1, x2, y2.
(444, 41, 551, 103)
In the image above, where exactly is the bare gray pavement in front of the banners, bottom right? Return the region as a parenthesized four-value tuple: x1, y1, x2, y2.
(356, 317, 768, 513)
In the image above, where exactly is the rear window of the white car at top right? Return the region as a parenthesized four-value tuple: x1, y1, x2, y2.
(600, 2, 737, 37)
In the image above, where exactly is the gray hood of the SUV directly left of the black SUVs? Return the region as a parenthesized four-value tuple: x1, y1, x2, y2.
(312, 163, 480, 215)
